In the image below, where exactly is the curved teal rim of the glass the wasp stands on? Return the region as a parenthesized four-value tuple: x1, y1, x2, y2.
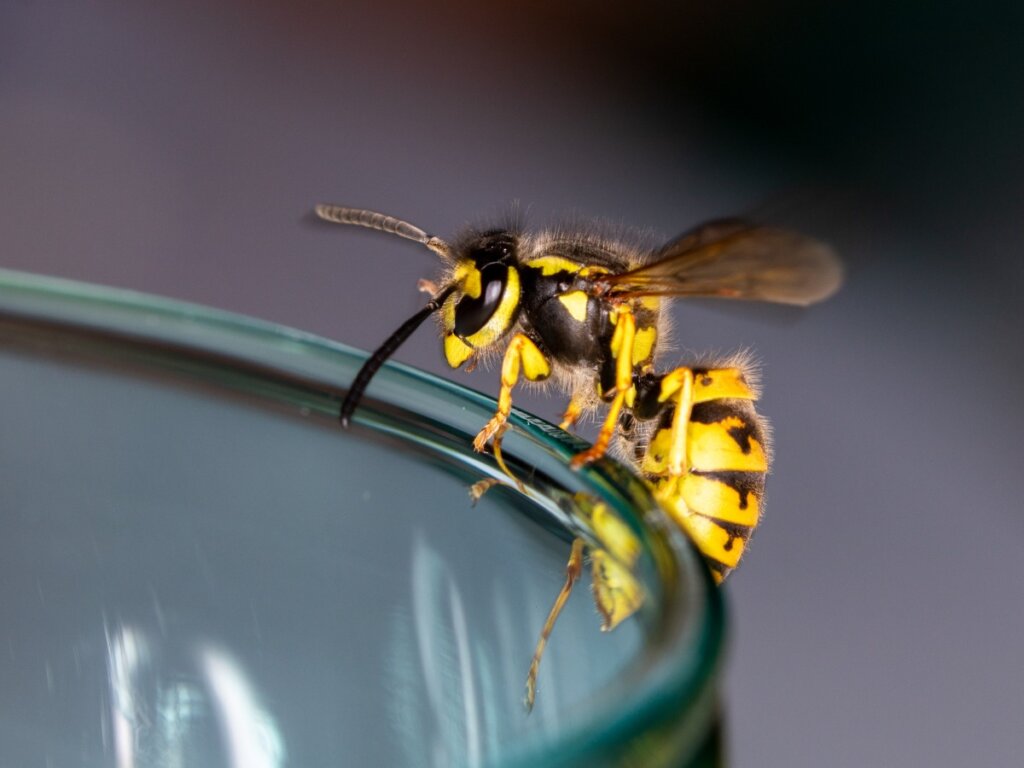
(0, 269, 724, 768)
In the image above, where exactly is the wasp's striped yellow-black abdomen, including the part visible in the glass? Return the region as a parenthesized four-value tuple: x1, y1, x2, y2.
(582, 367, 769, 663)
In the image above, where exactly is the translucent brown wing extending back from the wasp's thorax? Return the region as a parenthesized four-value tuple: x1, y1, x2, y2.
(600, 219, 843, 306)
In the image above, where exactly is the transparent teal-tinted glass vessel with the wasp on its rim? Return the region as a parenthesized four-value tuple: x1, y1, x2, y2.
(0, 270, 722, 768)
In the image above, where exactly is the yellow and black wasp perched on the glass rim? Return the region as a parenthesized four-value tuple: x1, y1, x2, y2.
(315, 205, 842, 708)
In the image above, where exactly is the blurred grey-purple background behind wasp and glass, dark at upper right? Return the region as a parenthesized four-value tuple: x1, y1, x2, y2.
(0, 0, 1024, 768)
